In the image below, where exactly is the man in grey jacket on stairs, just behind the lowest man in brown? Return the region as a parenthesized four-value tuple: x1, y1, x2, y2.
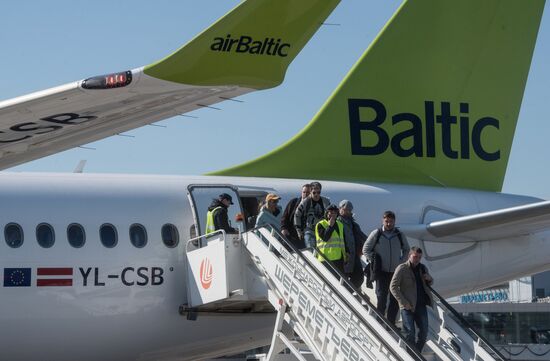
(363, 211, 410, 325)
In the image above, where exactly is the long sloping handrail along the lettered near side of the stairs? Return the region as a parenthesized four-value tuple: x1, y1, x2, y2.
(250, 224, 426, 361)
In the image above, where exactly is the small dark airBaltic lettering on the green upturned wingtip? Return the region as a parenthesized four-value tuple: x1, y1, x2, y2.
(210, 34, 290, 58)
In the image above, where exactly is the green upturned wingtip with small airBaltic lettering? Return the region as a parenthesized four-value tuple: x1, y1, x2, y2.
(144, 0, 340, 89)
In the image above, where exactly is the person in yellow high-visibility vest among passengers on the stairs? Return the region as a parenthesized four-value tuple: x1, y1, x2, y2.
(315, 204, 346, 276)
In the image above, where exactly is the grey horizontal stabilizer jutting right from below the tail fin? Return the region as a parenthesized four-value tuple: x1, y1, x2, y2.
(400, 201, 550, 242)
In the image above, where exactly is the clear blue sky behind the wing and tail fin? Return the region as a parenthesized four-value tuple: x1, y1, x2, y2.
(0, 0, 550, 199)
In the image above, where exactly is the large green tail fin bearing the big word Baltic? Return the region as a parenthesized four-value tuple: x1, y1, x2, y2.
(213, 0, 544, 191)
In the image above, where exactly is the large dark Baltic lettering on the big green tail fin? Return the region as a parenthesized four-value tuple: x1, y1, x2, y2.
(348, 99, 500, 161)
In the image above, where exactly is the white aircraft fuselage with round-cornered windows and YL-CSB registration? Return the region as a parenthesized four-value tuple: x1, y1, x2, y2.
(0, 173, 550, 361)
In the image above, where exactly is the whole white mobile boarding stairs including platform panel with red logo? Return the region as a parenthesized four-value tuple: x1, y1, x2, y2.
(180, 227, 505, 361)
